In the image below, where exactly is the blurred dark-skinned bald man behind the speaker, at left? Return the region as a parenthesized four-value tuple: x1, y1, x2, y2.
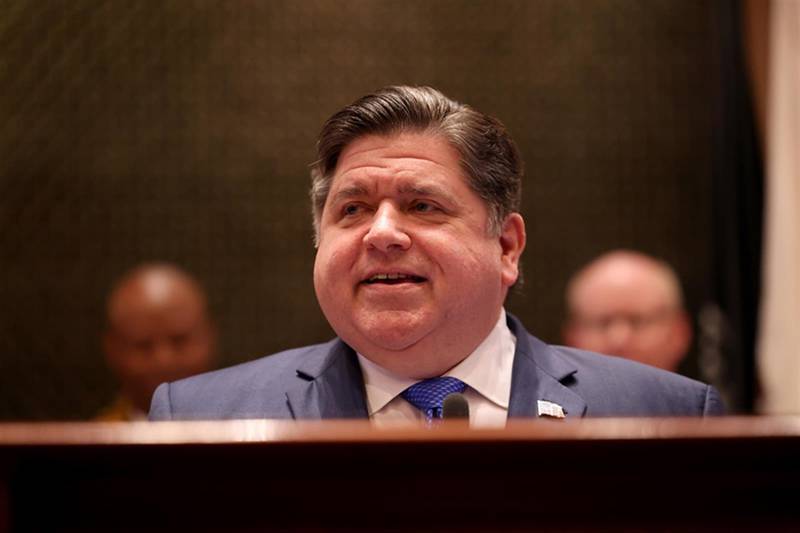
(97, 264, 216, 421)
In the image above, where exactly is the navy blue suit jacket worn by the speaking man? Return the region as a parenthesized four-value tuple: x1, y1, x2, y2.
(150, 315, 723, 420)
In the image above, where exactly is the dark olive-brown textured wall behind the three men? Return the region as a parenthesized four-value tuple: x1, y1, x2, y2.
(0, 0, 715, 419)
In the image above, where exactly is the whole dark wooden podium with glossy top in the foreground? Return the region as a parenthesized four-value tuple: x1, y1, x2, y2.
(0, 418, 800, 531)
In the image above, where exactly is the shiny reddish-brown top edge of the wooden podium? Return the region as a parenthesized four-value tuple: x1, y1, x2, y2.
(0, 416, 800, 446)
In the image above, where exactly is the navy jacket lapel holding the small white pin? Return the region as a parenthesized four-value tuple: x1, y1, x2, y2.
(508, 315, 586, 418)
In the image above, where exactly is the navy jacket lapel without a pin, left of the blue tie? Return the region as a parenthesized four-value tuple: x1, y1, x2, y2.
(286, 339, 368, 419)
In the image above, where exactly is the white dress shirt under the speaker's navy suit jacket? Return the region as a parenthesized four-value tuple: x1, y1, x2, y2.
(357, 309, 517, 428)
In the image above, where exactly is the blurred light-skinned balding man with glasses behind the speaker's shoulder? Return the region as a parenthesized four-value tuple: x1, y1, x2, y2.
(563, 250, 692, 372)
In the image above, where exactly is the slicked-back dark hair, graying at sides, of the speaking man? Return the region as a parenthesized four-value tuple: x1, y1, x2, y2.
(310, 86, 523, 244)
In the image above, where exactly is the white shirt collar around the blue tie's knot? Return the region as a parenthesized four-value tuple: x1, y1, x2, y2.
(356, 309, 516, 416)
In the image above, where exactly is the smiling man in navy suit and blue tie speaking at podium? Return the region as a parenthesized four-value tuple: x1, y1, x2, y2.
(150, 87, 722, 427)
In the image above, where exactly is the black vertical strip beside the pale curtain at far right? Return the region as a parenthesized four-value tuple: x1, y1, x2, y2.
(700, 0, 764, 413)
